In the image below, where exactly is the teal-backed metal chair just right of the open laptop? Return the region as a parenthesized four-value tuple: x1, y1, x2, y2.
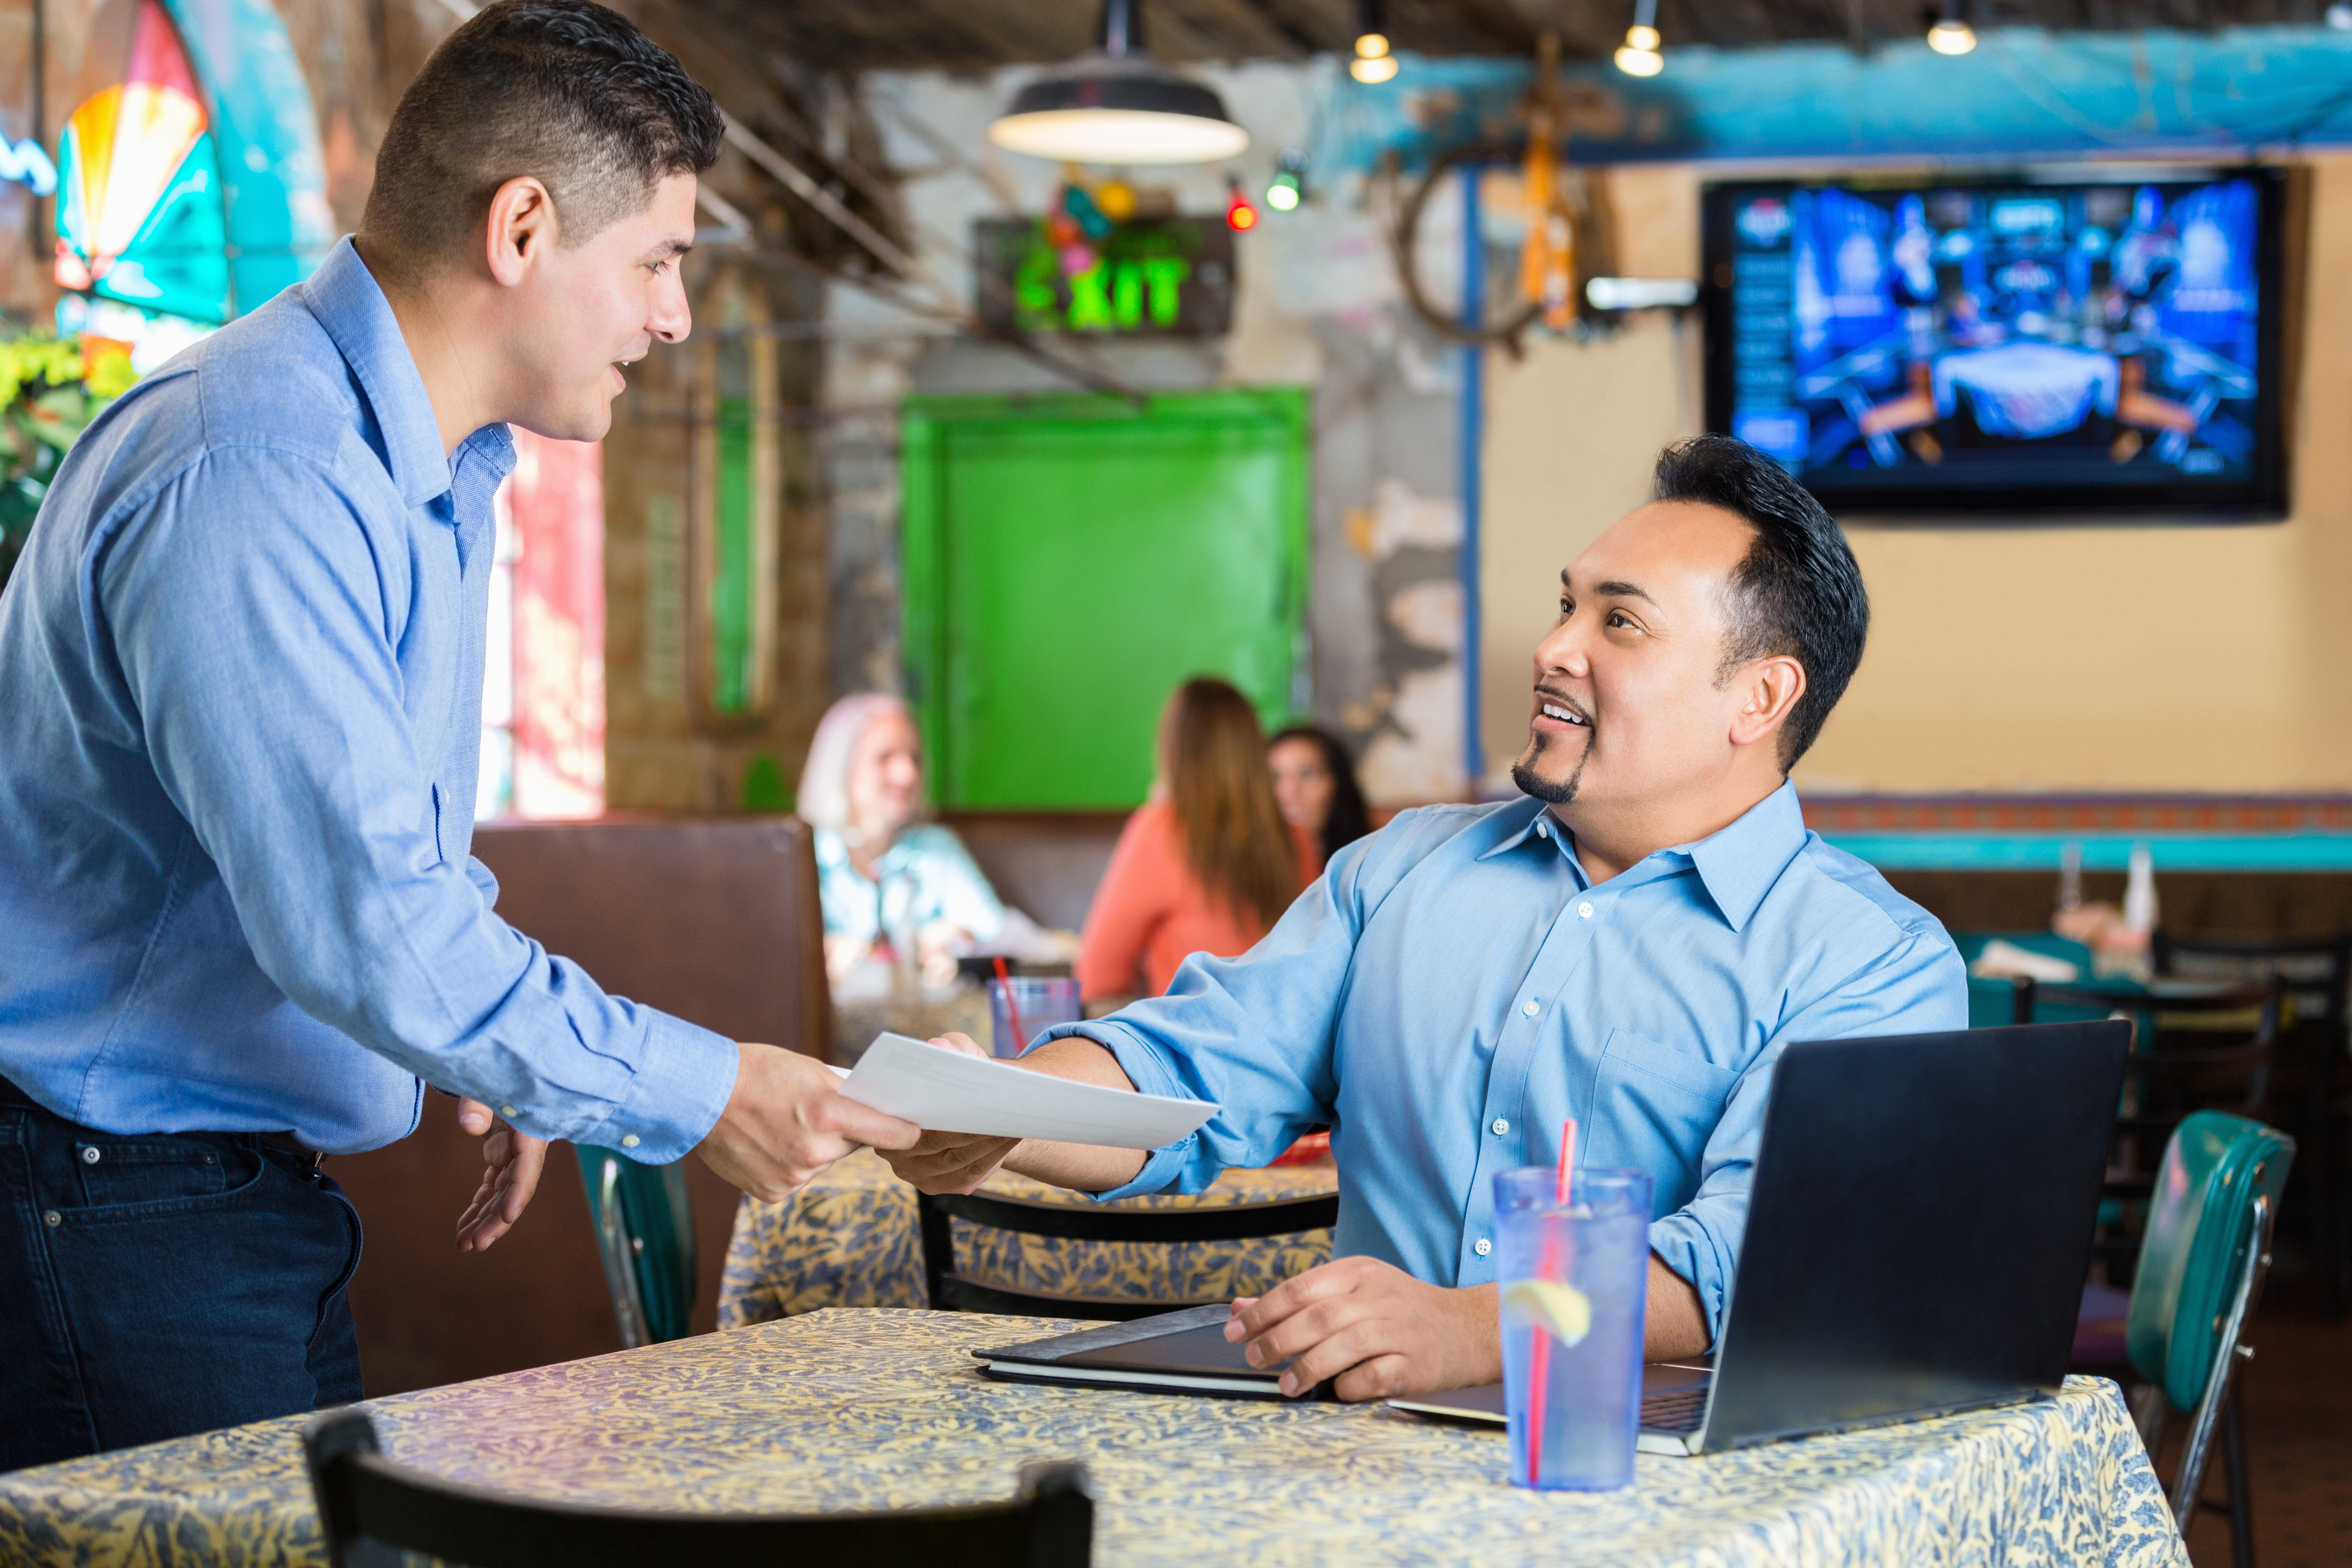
(2124, 1110, 2295, 1568)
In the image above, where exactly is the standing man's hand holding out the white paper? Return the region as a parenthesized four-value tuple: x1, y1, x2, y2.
(694, 1044, 922, 1203)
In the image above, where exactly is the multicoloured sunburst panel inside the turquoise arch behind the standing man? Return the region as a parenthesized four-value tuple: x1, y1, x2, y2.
(57, 0, 231, 324)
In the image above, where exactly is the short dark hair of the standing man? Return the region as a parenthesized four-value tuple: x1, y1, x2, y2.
(360, 0, 727, 273)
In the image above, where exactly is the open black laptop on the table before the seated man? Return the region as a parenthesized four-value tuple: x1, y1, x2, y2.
(1388, 1020, 2131, 1453)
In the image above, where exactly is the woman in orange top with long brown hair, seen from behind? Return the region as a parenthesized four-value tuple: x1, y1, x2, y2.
(1077, 677, 1320, 1001)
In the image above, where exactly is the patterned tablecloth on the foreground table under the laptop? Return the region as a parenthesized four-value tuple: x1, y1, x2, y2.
(0, 1312, 2188, 1568)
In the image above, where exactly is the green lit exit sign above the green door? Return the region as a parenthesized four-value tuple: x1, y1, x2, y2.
(971, 219, 1233, 338)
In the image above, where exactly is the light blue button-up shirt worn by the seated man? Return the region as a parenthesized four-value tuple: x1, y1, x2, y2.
(1054, 785, 1969, 1333)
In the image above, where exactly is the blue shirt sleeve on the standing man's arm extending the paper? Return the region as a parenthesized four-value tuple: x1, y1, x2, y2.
(89, 447, 736, 1161)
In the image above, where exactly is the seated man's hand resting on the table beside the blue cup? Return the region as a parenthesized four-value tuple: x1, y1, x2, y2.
(1225, 1258, 1503, 1401)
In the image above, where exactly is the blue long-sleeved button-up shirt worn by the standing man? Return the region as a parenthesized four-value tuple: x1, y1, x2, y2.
(0, 242, 736, 1161)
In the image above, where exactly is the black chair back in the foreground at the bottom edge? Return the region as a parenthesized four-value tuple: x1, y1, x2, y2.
(301, 1408, 1094, 1568)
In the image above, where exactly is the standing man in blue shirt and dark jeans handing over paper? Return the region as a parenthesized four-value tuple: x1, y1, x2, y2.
(0, 0, 917, 1469)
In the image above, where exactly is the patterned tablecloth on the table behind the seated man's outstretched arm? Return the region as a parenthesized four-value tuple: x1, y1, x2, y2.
(719, 1150, 1339, 1328)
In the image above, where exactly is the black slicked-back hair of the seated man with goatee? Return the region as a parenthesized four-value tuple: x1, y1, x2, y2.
(1651, 435, 1870, 774)
